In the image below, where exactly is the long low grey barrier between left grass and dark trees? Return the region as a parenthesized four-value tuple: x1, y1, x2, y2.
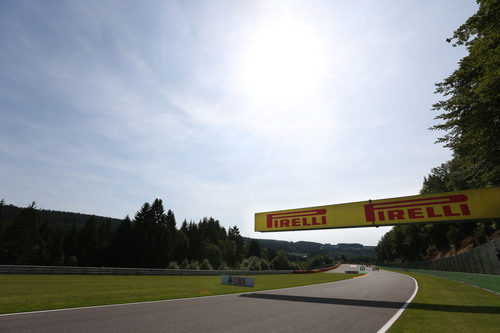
(0, 265, 294, 275)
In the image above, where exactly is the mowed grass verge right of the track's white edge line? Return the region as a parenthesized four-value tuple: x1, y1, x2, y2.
(389, 270, 500, 333)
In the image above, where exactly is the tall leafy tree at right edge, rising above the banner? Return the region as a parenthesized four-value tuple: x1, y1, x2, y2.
(431, 0, 500, 189)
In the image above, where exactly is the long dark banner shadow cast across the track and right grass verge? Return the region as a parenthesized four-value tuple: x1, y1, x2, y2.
(240, 293, 500, 314)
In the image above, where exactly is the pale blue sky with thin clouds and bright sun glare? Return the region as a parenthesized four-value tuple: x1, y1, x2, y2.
(0, 0, 477, 245)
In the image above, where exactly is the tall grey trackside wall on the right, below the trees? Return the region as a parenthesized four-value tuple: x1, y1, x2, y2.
(380, 238, 500, 275)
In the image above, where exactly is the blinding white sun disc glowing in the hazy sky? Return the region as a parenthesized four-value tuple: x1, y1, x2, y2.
(240, 19, 325, 106)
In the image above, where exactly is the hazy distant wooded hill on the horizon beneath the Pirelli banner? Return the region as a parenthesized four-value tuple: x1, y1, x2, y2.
(243, 237, 375, 259)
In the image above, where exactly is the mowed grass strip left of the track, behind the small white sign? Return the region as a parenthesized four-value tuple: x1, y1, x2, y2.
(0, 273, 354, 313)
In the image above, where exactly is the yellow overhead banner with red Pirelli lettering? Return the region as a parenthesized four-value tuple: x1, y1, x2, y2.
(255, 187, 500, 231)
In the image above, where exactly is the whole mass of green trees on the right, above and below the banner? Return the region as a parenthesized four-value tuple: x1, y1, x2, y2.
(375, 0, 500, 263)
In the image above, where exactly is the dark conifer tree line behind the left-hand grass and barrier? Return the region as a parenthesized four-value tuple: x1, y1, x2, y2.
(0, 199, 345, 270)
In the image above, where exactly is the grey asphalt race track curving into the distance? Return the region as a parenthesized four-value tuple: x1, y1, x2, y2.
(0, 265, 416, 332)
